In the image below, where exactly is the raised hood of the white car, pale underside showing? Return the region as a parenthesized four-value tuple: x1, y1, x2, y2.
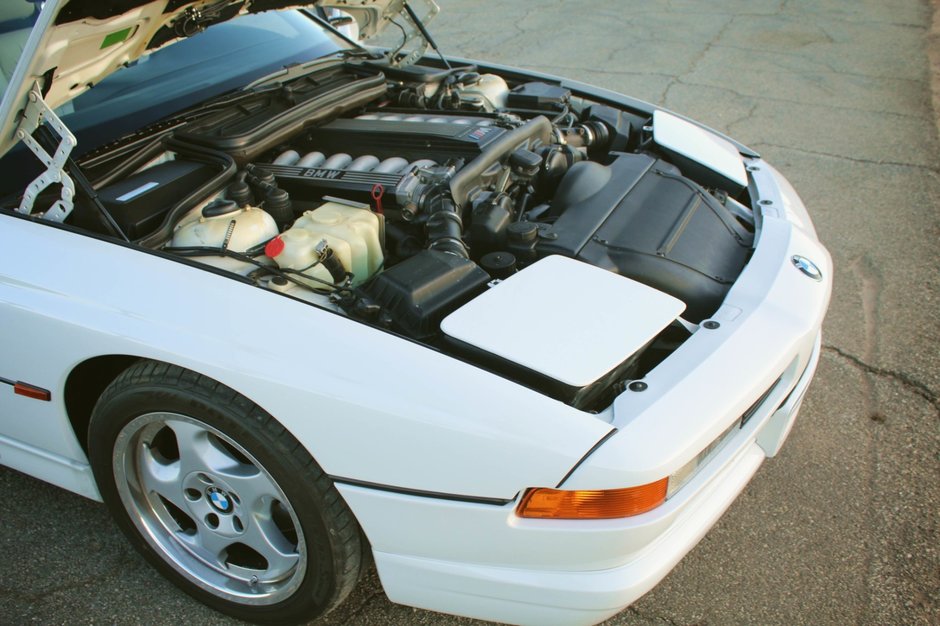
(0, 0, 403, 154)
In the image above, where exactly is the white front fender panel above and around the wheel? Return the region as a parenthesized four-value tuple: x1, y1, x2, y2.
(0, 215, 611, 499)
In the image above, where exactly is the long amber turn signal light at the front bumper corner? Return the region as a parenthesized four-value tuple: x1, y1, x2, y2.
(516, 478, 669, 519)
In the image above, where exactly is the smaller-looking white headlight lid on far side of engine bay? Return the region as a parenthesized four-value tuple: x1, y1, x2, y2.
(653, 111, 747, 187)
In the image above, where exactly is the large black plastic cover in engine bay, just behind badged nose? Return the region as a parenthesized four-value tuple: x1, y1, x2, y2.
(536, 154, 753, 322)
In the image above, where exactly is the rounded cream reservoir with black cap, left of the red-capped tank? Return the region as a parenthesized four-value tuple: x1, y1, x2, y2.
(170, 200, 278, 275)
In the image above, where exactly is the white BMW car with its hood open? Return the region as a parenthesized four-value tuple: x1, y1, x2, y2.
(0, 0, 832, 624)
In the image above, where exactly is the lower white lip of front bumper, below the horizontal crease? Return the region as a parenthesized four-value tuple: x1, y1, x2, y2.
(364, 444, 764, 626)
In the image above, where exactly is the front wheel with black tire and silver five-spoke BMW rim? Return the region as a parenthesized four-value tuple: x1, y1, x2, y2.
(88, 361, 363, 624)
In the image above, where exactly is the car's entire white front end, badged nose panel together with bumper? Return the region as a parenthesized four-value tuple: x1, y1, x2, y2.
(338, 159, 832, 624)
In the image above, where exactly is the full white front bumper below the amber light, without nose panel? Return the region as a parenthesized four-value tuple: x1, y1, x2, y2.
(339, 334, 819, 626)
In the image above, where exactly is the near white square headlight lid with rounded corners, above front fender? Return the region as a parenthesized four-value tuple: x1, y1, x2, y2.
(441, 256, 685, 387)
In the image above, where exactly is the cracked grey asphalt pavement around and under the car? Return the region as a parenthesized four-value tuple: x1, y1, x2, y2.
(0, 0, 940, 626)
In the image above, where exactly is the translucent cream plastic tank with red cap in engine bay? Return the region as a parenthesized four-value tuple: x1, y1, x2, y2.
(267, 202, 384, 289)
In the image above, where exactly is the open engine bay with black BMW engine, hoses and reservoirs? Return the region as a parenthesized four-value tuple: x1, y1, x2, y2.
(46, 61, 755, 410)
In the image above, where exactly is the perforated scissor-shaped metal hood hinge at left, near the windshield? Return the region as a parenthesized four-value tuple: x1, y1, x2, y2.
(16, 83, 78, 222)
